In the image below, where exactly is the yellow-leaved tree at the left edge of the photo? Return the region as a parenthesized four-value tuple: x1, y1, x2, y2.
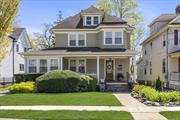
(0, 0, 21, 62)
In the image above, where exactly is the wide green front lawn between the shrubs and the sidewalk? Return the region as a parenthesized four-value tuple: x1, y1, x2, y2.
(0, 92, 122, 106)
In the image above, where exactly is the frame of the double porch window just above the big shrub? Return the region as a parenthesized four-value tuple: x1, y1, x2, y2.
(68, 58, 87, 74)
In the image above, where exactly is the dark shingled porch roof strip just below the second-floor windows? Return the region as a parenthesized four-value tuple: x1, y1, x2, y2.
(42, 47, 126, 52)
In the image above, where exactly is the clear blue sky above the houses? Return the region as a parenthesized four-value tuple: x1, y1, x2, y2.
(17, 0, 180, 35)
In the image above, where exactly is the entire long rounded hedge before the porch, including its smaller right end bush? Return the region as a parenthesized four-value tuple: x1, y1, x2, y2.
(36, 70, 96, 93)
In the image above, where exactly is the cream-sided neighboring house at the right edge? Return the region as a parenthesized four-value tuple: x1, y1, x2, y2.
(138, 5, 180, 89)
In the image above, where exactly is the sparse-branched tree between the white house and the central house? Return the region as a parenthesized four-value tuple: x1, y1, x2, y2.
(34, 11, 63, 49)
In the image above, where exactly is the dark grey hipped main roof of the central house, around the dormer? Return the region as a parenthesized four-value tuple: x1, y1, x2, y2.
(53, 6, 128, 29)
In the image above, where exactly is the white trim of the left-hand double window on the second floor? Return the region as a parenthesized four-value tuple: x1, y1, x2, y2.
(68, 32, 86, 47)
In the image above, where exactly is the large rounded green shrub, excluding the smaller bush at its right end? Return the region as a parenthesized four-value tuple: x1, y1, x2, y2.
(36, 70, 81, 93)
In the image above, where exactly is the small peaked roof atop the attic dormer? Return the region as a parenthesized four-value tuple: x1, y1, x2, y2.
(81, 5, 103, 14)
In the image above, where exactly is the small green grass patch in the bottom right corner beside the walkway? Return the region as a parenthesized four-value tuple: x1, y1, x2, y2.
(160, 111, 180, 120)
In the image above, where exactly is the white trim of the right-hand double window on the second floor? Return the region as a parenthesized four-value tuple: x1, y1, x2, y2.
(103, 30, 124, 45)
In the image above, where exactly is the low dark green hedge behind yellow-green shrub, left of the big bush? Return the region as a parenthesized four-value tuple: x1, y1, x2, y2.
(15, 73, 42, 83)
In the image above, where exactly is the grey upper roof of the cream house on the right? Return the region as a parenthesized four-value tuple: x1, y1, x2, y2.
(149, 14, 178, 26)
